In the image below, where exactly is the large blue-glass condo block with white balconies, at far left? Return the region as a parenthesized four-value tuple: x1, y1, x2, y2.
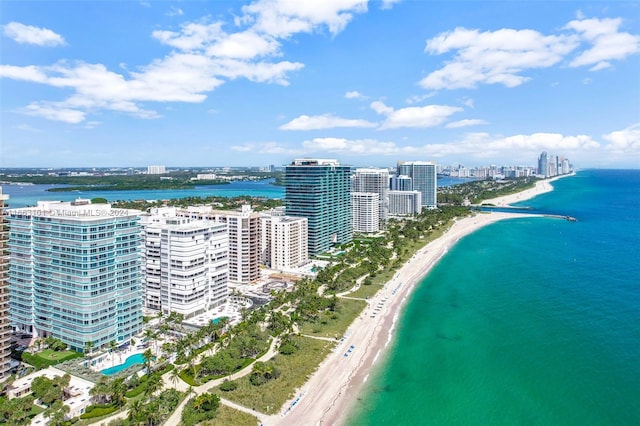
(8, 199, 142, 351)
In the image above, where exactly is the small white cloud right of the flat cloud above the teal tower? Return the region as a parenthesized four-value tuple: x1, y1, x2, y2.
(371, 101, 462, 129)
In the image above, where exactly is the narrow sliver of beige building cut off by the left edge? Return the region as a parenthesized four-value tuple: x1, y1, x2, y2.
(0, 187, 11, 380)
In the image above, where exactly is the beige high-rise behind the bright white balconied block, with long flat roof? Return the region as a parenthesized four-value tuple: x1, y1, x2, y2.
(178, 205, 261, 284)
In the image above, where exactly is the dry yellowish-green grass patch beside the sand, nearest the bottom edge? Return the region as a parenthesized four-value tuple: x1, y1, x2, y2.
(213, 337, 335, 412)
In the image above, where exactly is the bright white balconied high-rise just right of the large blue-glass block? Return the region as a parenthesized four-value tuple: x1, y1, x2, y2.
(142, 208, 228, 318)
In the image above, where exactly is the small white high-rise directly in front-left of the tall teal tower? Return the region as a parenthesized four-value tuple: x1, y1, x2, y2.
(260, 214, 309, 271)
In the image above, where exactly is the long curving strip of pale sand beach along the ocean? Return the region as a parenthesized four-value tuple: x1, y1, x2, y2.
(263, 174, 574, 425)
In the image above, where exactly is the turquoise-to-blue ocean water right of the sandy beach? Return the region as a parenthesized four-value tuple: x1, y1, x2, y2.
(347, 170, 640, 426)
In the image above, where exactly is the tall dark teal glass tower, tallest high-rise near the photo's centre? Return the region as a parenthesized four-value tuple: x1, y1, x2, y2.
(284, 158, 352, 255)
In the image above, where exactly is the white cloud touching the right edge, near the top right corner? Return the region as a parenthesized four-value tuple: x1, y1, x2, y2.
(566, 18, 640, 71)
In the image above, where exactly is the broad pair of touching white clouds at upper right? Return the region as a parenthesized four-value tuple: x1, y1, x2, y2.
(419, 14, 640, 90)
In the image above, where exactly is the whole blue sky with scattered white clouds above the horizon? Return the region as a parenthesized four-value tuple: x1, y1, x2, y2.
(0, 0, 640, 168)
